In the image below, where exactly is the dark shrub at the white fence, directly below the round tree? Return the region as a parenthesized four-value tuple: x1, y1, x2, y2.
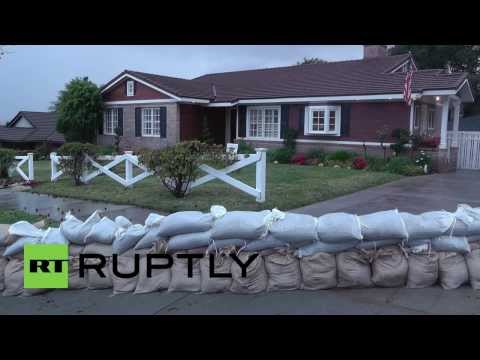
(58, 142, 96, 186)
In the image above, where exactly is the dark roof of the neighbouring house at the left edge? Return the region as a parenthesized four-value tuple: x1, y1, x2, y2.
(0, 111, 65, 143)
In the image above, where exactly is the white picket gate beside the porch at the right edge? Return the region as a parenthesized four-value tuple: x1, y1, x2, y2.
(448, 131, 480, 170)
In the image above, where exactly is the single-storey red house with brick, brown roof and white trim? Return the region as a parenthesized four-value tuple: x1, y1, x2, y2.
(98, 45, 473, 170)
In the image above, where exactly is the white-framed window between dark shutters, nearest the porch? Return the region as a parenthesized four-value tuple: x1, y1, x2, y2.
(305, 106, 341, 135)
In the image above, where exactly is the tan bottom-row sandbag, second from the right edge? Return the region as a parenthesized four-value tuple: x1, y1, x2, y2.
(438, 252, 468, 290)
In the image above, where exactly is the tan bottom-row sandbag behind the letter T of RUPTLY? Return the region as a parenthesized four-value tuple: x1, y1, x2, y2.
(168, 254, 202, 292)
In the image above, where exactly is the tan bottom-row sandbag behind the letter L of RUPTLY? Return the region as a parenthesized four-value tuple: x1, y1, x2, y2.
(200, 249, 233, 294)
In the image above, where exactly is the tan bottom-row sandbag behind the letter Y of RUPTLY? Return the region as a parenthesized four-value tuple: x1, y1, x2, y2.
(230, 251, 267, 294)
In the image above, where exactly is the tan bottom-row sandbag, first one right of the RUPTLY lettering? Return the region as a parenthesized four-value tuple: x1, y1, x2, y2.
(263, 249, 302, 291)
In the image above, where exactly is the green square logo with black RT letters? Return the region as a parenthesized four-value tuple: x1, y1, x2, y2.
(23, 244, 68, 289)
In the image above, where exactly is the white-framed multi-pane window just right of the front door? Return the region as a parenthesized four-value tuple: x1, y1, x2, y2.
(247, 106, 280, 139)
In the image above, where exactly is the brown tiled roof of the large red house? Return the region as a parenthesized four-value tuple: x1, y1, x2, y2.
(103, 54, 467, 102)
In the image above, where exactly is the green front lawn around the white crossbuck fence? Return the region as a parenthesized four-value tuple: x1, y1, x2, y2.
(25, 161, 401, 213)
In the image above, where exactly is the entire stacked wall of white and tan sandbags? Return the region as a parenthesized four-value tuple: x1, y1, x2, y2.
(0, 204, 480, 296)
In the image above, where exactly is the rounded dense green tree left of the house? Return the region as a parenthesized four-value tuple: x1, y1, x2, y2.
(52, 77, 103, 142)
